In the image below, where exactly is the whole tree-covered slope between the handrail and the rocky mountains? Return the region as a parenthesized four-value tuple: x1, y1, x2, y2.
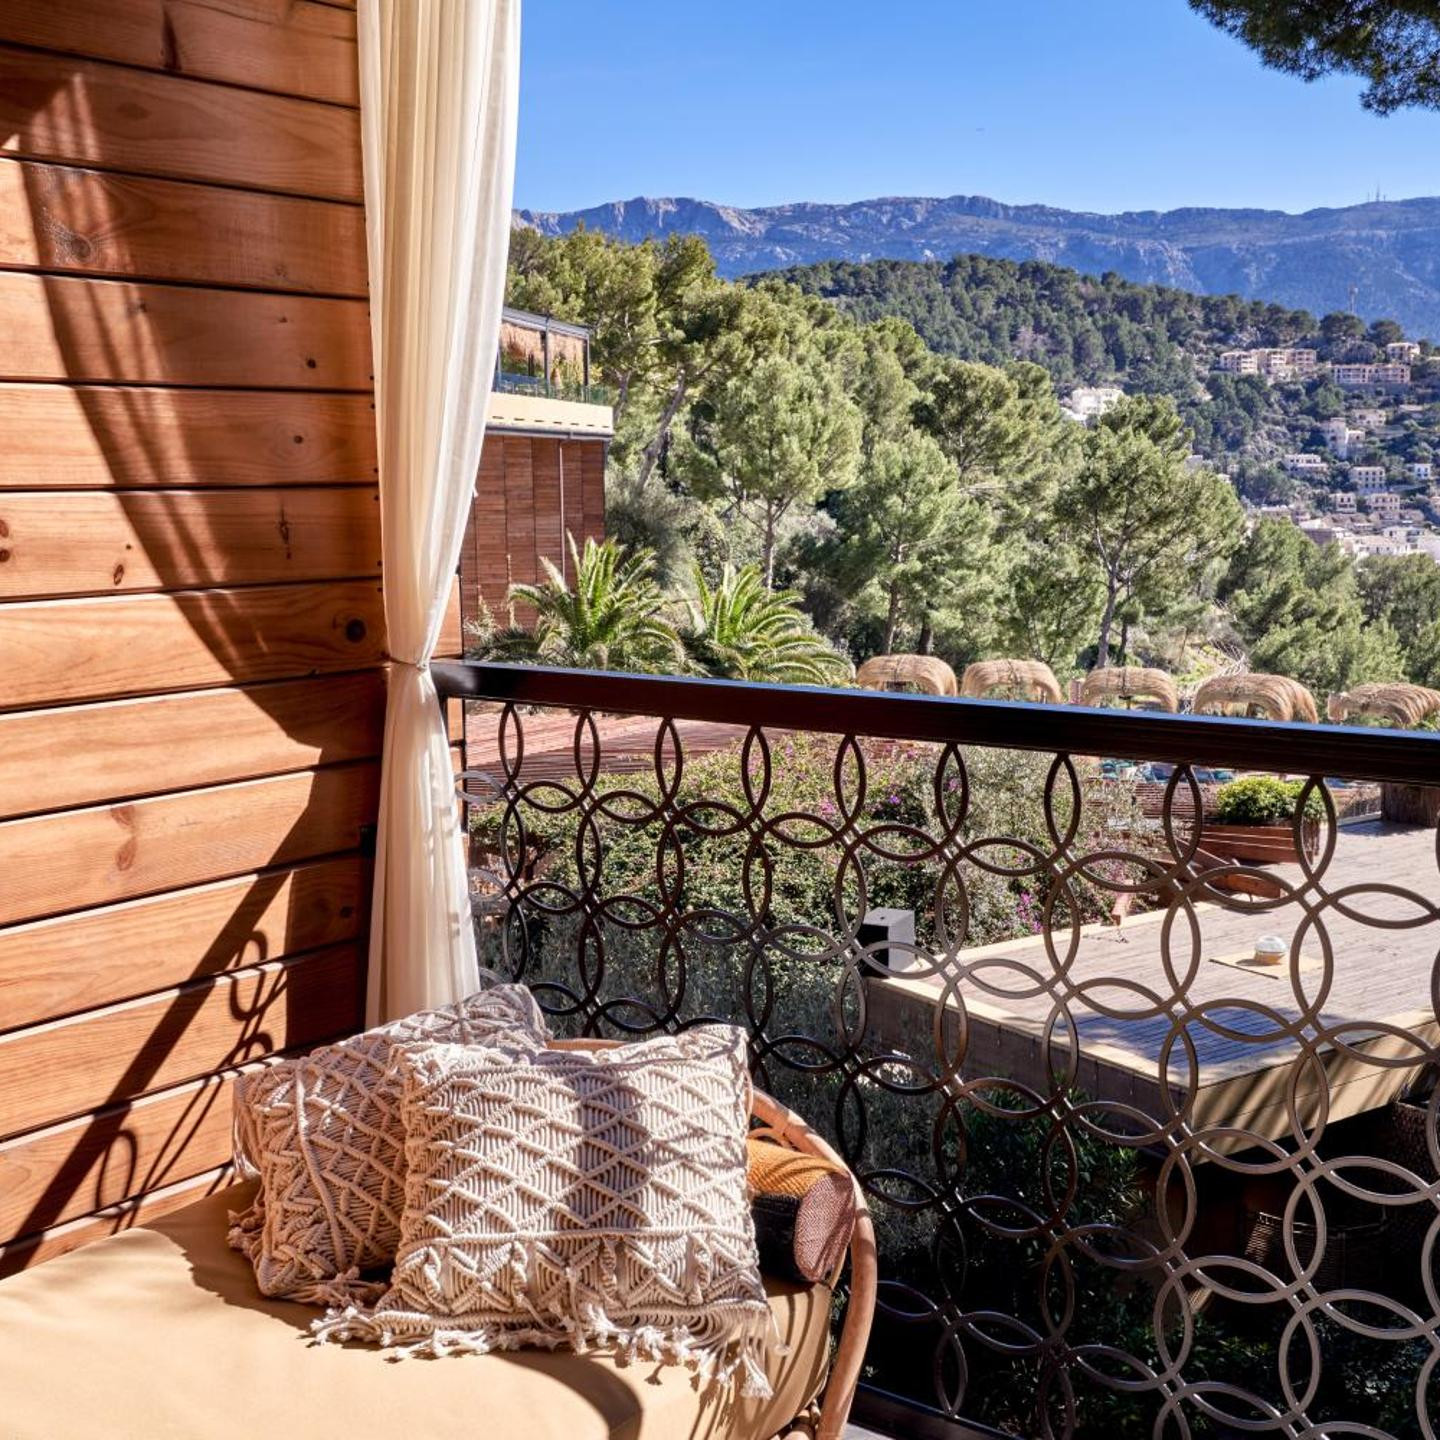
(497, 230, 1440, 694)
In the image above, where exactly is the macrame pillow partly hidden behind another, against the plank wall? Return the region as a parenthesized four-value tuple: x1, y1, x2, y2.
(230, 985, 546, 1305)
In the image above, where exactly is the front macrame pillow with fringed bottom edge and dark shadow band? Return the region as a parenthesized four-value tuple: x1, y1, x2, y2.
(314, 1025, 775, 1397)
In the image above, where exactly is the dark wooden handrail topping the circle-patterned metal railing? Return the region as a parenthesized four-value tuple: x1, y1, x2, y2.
(431, 661, 1440, 785)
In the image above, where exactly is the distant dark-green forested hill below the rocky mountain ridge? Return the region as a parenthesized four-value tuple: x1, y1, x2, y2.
(765, 255, 1440, 503)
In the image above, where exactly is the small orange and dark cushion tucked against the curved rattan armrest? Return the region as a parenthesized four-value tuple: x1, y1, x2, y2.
(746, 1138, 855, 1284)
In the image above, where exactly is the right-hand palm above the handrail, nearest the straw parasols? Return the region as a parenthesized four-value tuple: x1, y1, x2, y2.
(680, 564, 850, 685)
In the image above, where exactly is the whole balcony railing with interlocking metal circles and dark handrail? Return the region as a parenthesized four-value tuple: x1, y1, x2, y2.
(435, 664, 1440, 1440)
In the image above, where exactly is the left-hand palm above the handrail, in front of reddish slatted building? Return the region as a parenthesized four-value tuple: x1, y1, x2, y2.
(494, 536, 684, 674)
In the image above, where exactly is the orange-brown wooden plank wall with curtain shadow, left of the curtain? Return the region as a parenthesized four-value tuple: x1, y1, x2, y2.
(0, 0, 458, 1270)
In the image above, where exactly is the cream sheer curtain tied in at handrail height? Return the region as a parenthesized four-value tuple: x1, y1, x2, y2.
(359, 0, 520, 1024)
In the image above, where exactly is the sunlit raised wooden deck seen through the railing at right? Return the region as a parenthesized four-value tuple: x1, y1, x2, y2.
(871, 822, 1440, 1148)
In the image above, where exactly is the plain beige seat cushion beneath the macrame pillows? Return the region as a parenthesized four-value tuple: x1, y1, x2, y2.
(0, 1185, 829, 1440)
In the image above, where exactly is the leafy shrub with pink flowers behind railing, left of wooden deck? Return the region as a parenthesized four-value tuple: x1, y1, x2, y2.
(471, 734, 1135, 949)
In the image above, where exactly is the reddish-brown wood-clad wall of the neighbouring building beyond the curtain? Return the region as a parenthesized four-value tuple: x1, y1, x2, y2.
(459, 432, 606, 625)
